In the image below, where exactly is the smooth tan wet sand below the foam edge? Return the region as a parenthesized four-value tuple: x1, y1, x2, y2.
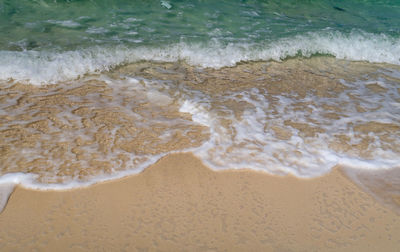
(0, 154, 400, 251)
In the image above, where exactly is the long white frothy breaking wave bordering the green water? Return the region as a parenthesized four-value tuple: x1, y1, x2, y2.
(0, 29, 400, 84)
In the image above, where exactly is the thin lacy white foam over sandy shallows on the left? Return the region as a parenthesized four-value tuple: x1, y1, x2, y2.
(0, 75, 206, 191)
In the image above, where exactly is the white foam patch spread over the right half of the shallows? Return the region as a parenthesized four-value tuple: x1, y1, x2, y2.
(180, 77, 400, 178)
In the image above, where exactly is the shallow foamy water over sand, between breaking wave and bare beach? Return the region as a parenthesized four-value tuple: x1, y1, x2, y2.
(0, 57, 400, 186)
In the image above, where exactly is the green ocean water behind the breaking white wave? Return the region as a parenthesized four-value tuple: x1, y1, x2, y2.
(0, 0, 400, 51)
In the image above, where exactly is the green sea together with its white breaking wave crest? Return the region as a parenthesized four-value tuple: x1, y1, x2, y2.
(0, 0, 400, 84)
